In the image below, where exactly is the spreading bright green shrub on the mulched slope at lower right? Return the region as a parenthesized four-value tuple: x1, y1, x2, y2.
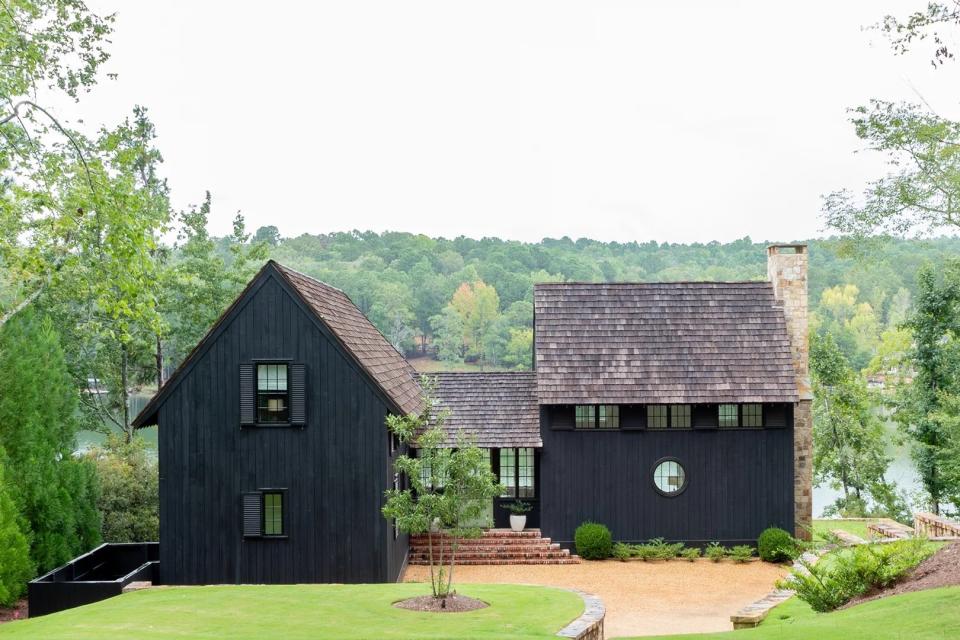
(780, 539, 935, 613)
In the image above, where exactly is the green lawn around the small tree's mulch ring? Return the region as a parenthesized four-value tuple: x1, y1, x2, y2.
(0, 583, 583, 640)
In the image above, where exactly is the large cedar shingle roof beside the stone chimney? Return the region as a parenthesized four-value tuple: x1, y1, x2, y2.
(534, 282, 797, 404)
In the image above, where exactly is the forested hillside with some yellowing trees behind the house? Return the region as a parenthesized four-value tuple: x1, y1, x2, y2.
(253, 227, 960, 370)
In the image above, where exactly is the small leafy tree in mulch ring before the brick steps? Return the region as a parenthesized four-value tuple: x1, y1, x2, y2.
(383, 383, 503, 606)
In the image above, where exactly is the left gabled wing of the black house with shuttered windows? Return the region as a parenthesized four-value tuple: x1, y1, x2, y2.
(135, 261, 422, 584)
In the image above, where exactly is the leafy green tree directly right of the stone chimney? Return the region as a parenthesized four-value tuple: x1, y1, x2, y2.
(810, 334, 896, 515)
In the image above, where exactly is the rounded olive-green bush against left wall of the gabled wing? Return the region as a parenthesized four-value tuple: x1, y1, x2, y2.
(86, 434, 160, 542)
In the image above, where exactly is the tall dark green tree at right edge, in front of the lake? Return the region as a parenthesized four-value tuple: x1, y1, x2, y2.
(894, 260, 960, 513)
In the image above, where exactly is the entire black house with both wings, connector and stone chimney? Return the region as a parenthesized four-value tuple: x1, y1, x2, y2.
(135, 245, 812, 584)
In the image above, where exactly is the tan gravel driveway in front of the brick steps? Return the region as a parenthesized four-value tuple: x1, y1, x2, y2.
(404, 560, 787, 638)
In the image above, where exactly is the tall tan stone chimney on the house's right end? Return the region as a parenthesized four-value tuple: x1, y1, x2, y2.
(767, 244, 813, 539)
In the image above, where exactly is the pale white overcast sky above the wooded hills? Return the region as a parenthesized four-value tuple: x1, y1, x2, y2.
(60, 0, 960, 242)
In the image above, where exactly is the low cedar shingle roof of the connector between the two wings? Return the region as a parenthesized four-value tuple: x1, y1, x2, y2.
(420, 371, 543, 448)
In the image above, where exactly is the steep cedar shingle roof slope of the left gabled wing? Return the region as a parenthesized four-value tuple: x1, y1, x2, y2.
(275, 263, 423, 413)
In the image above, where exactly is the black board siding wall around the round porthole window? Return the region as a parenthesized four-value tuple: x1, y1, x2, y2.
(538, 405, 794, 546)
